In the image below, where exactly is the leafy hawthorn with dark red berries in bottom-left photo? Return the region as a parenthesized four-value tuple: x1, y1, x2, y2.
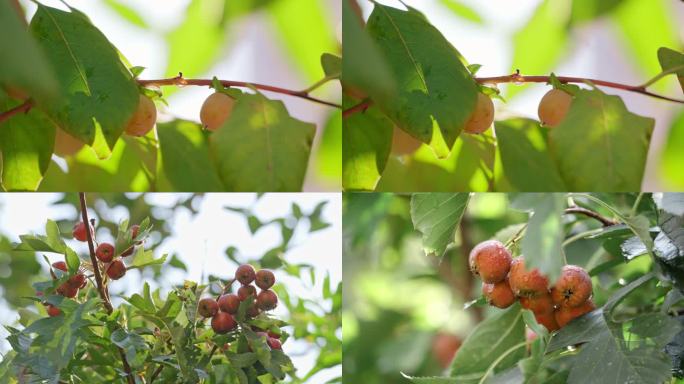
(0, 193, 341, 383)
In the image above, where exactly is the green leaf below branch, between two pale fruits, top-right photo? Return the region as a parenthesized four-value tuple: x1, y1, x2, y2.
(494, 118, 566, 192)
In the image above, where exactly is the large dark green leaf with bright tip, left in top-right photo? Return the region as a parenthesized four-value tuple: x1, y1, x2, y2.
(367, 4, 477, 157)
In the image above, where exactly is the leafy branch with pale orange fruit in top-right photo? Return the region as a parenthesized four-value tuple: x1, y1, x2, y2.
(342, 0, 684, 192)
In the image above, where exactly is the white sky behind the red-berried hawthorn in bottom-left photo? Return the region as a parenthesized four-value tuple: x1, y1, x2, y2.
(0, 193, 342, 383)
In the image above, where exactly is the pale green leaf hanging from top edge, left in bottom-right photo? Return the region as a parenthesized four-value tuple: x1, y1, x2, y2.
(411, 193, 470, 257)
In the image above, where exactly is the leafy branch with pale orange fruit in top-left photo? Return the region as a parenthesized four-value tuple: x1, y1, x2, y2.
(0, 0, 341, 192)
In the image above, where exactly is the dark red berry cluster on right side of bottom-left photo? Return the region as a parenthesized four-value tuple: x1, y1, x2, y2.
(197, 264, 281, 349)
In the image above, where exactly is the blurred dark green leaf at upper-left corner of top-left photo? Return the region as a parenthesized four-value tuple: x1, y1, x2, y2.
(0, 1, 58, 101)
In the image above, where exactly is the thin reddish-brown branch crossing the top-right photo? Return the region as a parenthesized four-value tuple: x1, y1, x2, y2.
(342, 73, 684, 117)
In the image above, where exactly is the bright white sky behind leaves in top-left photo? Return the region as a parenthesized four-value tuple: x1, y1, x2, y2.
(21, 0, 341, 191)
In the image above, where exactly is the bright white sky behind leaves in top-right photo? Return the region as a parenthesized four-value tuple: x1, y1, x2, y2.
(358, 0, 684, 190)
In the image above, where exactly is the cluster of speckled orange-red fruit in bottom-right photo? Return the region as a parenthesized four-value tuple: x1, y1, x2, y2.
(468, 240, 596, 331)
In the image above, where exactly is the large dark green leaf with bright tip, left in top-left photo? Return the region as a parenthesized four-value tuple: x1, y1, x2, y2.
(31, 5, 138, 157)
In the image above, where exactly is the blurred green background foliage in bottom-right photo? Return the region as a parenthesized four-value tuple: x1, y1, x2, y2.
(343, 193, 663, 384)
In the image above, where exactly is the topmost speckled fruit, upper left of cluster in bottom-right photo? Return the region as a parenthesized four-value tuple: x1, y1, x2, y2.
(468, 240, 511, 283)
